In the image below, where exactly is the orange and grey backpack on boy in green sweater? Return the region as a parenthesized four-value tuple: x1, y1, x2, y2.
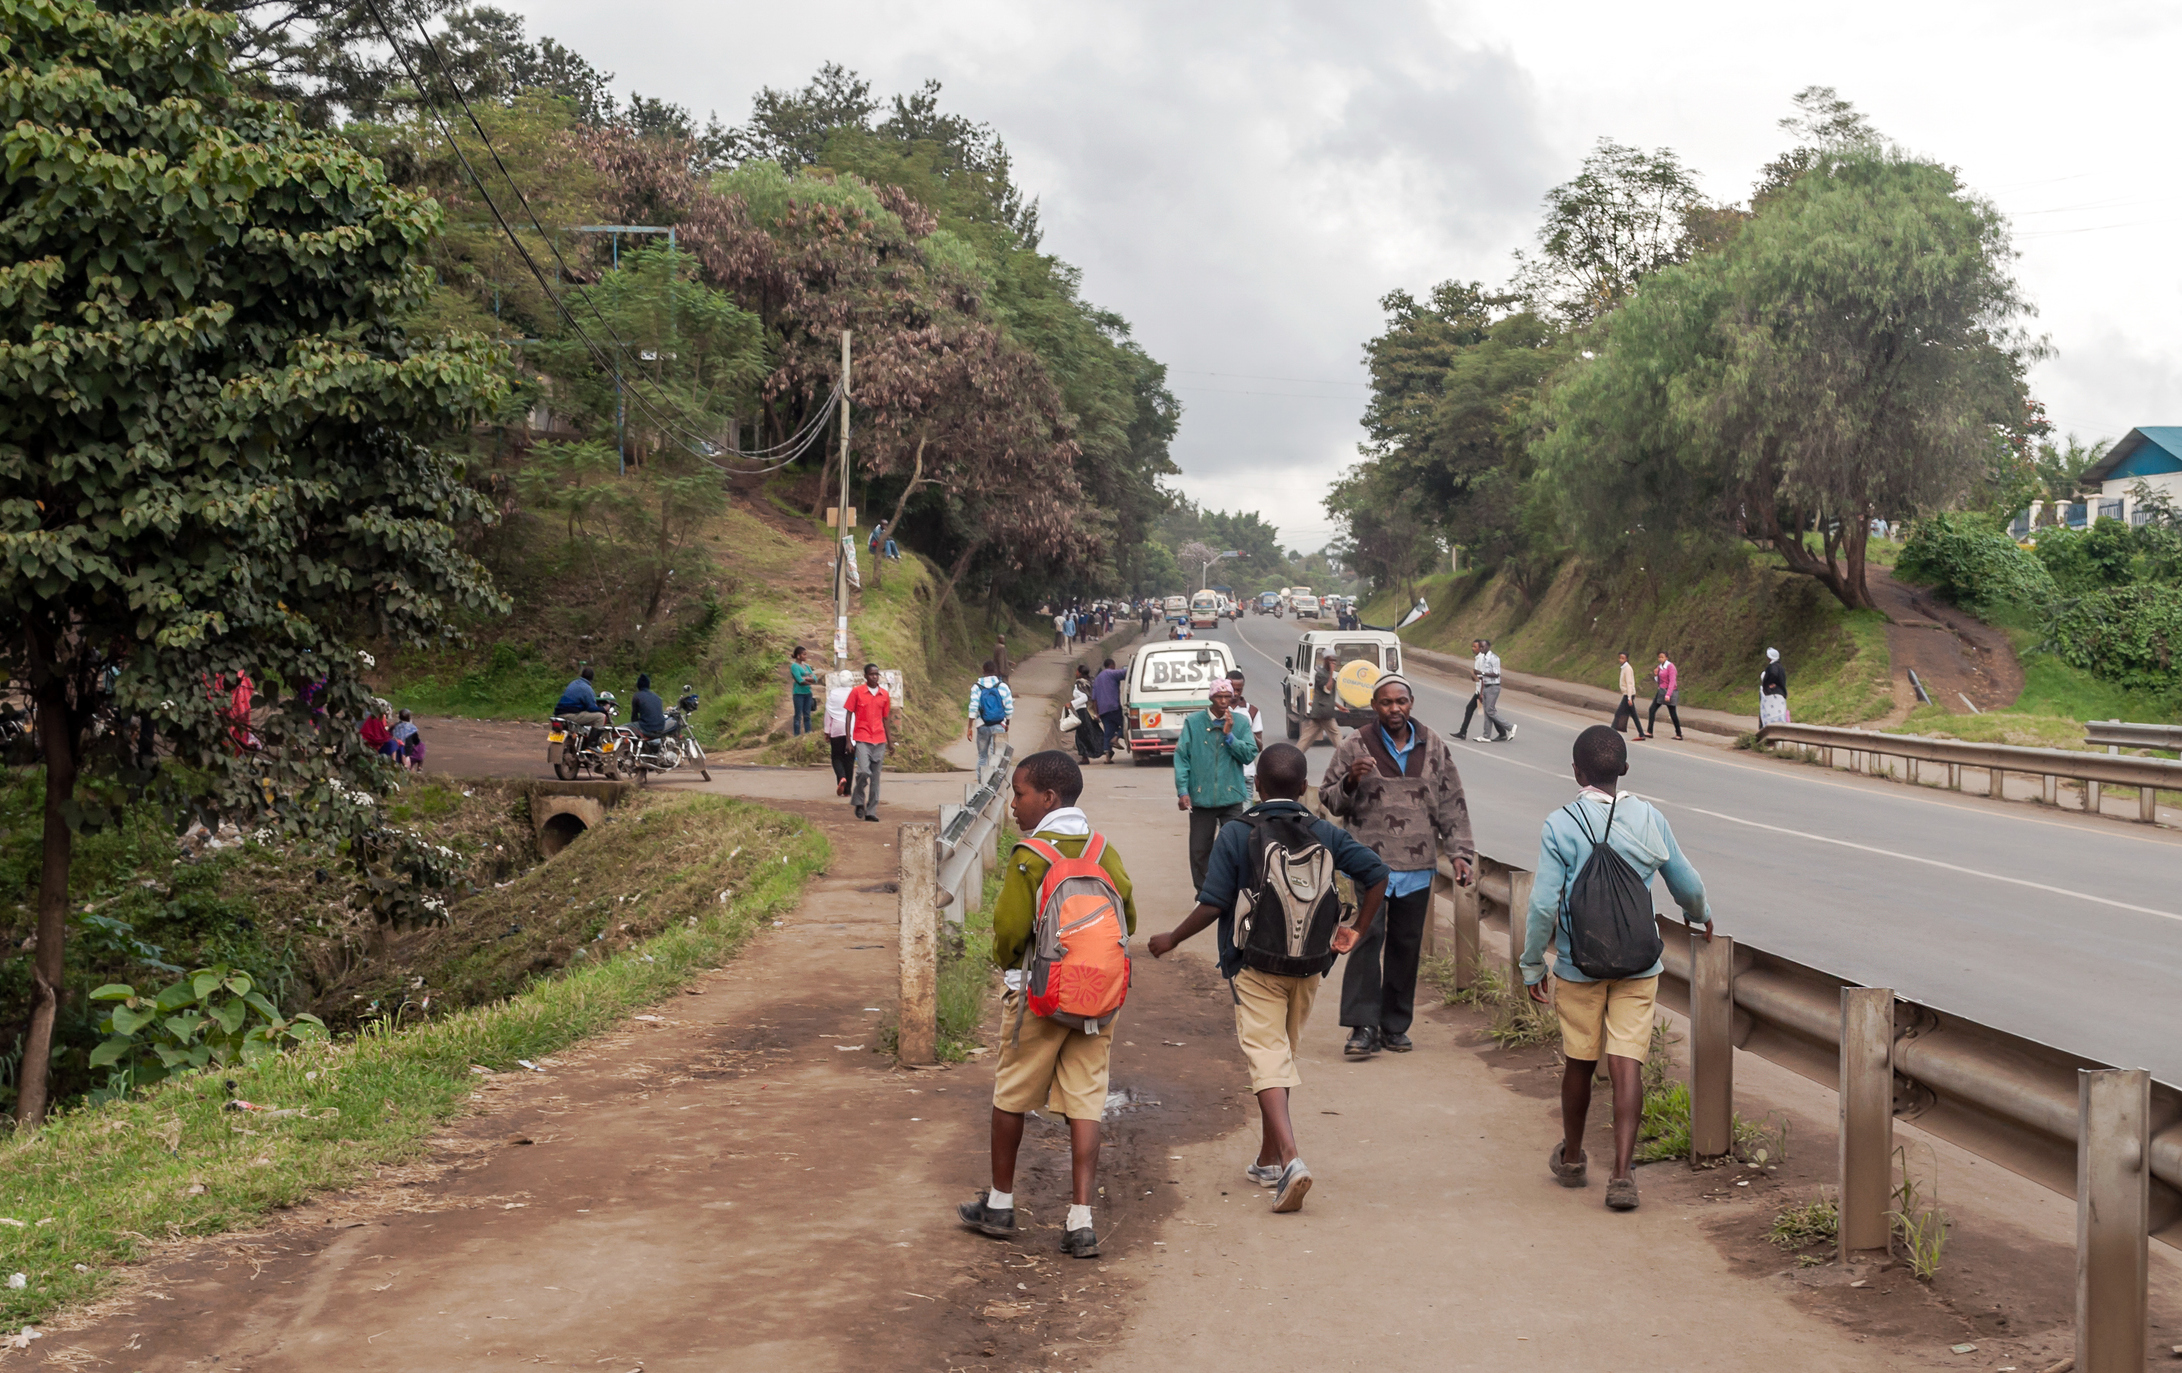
(1017, 834, 1130, 1035)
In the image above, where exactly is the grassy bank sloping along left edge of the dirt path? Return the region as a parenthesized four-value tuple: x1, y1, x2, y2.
(0, 795, 827, 1325)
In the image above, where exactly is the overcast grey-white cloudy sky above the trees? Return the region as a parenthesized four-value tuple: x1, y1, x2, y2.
(514, 0, 2182, 548)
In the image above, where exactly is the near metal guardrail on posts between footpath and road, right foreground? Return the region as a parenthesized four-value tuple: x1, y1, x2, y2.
(1427, 842, 2182, 1373)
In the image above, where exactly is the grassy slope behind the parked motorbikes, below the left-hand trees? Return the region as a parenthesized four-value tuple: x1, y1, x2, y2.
(382, 487, 1028, 771)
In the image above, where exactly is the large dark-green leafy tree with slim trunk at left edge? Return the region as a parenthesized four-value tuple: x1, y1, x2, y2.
(0, 0, 502, 1124)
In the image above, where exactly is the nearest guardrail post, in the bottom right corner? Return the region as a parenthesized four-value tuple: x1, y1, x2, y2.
(2075, 1067, 2151, 1373)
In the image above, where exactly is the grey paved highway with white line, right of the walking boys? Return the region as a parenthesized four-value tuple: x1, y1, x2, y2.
(1207, 616, 2182, 1085)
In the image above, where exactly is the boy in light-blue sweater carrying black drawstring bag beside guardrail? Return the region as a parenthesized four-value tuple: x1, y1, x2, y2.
(1521, 725, 1713, 1211)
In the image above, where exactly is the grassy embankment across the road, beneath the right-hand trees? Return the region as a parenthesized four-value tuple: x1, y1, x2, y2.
(1364, 545, 1892, 725)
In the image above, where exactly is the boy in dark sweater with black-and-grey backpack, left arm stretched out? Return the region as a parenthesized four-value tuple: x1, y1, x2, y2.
(1150, 744, 1388, 1214)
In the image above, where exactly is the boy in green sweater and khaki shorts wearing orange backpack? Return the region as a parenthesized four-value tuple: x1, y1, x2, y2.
(956, 749, 1137, 1259)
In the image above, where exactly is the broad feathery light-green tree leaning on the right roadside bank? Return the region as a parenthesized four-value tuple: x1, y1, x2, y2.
(1538, 148, 2036, 609)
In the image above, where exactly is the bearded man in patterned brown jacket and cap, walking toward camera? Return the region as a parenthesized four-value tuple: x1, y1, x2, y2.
(1318, 672, 1477, 1059)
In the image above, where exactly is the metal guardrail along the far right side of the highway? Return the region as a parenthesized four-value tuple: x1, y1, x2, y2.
(1759, 725, 2182, 825)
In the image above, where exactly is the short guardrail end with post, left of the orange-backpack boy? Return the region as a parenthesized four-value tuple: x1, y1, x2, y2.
(895, 744, 1015, 1063)
